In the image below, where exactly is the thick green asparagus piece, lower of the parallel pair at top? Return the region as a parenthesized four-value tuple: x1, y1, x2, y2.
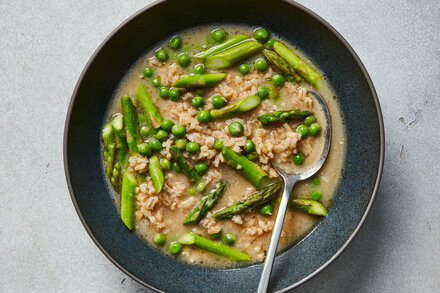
(205, 40, 263, 69)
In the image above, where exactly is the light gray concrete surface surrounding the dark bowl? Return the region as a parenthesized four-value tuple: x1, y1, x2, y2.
(0, 0, 440, 293)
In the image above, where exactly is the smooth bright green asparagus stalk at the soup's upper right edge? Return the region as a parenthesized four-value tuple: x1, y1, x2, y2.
(273, 41, 322, 89)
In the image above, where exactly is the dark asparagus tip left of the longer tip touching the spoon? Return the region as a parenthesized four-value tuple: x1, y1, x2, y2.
(183, 182, 226, 225)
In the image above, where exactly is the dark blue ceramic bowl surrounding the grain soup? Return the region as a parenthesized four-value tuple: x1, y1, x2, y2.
(64, 0, 384, 292)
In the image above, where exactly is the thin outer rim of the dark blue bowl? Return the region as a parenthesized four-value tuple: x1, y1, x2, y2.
(63, 0, 385, 292)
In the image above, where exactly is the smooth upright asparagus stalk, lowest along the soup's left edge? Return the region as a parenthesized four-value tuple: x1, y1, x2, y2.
(121, 170, 137, 230)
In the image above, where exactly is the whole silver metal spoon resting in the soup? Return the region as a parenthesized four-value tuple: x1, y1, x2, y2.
(258, 91, 332, 293)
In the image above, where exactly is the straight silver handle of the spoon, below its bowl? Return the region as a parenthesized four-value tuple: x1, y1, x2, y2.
(257, 180, 296, 293)
